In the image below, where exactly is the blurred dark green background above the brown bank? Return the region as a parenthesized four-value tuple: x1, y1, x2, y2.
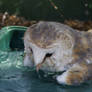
(0, 0, 92, 21)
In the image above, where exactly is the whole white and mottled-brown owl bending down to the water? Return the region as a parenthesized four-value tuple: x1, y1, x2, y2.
(24, 21, 92, 85)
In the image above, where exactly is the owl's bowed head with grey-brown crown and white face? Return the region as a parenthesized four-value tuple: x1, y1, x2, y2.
(24, 22, 74, 70)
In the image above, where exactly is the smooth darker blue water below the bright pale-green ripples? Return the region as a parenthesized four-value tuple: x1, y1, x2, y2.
(0, 63, 92, 92)
